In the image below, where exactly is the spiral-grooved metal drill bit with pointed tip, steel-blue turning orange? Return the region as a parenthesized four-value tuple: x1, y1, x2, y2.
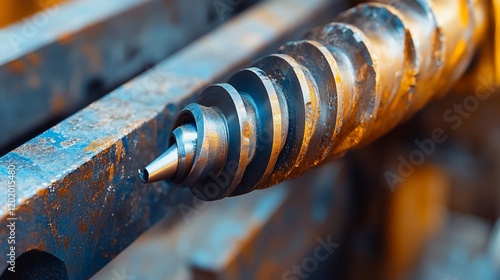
(141, 0, 488, 200)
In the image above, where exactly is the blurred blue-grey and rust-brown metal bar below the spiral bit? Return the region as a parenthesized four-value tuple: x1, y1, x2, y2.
(92, 162, 352, 280)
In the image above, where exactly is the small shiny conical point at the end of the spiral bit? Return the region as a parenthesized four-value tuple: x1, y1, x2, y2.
(139, 144, 179, 183)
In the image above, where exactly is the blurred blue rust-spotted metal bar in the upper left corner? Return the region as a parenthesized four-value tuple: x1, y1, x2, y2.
(0, 0, 239, 151)
